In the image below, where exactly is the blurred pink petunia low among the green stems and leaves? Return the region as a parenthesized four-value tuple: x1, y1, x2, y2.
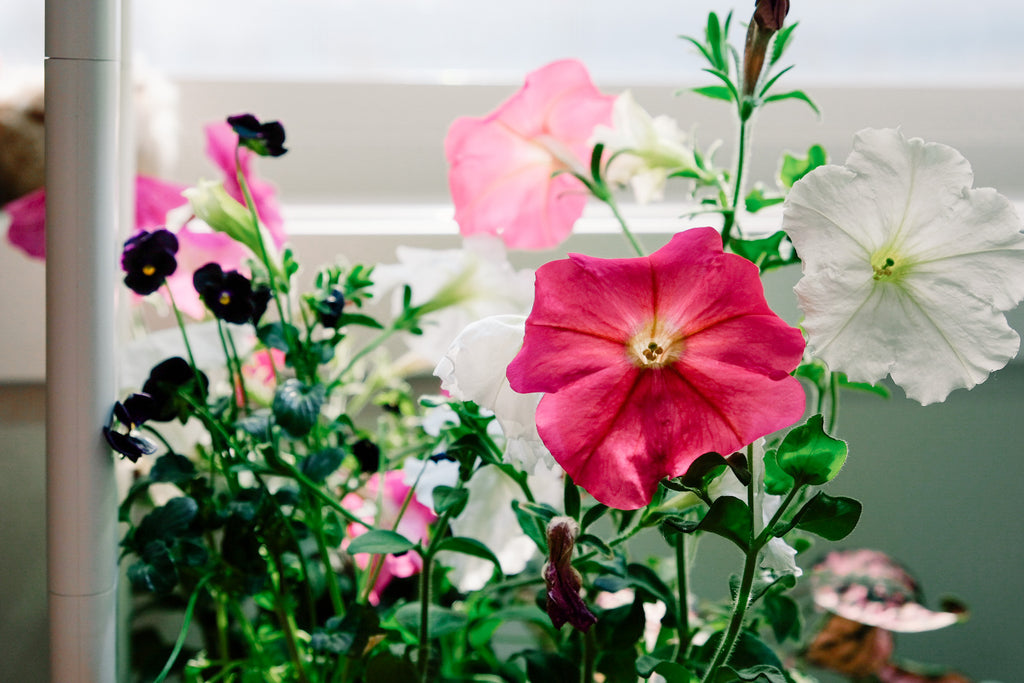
(341, 470, 437, 604)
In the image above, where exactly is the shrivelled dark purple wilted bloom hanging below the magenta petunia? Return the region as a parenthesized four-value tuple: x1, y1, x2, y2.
(544, 517, 597, 633)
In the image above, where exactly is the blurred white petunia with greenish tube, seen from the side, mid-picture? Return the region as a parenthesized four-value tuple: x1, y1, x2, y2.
(374, 234, 534, 367)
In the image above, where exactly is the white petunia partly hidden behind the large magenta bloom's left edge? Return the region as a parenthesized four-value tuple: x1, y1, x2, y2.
(434, 315, 555, 473)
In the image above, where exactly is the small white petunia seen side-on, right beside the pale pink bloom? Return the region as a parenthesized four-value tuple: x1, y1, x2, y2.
(593, 90, 697, 204)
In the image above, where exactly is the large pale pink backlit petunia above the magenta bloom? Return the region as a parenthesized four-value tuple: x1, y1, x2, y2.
(444, 59, 614, 249)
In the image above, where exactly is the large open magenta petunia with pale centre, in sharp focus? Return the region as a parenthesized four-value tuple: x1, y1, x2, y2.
(507, 227, 805, 509)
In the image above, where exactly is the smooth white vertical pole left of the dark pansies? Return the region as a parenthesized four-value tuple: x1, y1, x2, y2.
(45, 0, 120, 683)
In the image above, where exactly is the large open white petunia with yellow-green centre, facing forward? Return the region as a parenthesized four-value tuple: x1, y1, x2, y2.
(782, 130, 1024, 404)
